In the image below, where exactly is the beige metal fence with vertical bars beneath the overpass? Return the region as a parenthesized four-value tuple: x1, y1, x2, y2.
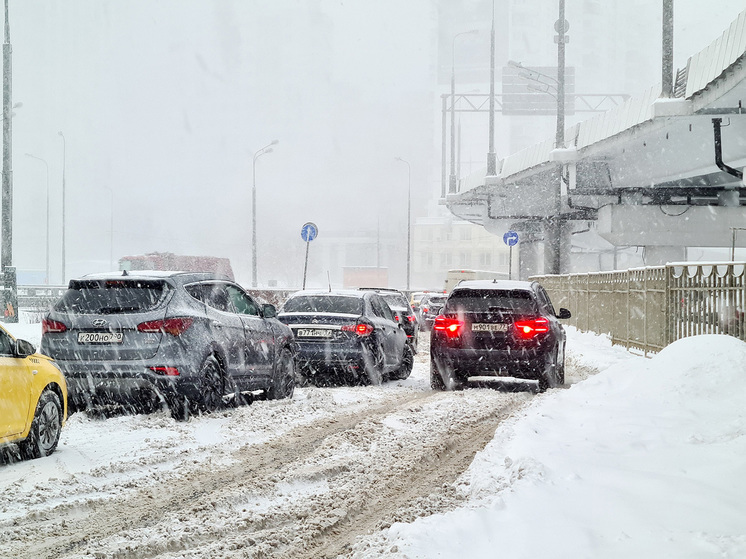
(531, 262, 746, 354)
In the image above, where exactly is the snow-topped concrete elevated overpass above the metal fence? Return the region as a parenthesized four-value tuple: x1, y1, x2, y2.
(445, 11, 746, 277)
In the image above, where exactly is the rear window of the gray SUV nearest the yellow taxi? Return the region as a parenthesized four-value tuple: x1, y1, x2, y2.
(54, 280, 169, 314)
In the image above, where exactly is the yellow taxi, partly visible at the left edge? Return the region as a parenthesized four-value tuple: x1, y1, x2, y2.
(0, 326, 67, 458)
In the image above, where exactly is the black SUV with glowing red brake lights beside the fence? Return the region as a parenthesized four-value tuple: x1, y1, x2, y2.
(430, 280, 570, 391)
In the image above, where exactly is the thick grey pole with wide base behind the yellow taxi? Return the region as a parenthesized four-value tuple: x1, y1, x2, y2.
(0, 0, 18, 322)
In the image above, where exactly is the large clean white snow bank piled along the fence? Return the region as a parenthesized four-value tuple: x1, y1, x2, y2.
(366, 335, 746, 559)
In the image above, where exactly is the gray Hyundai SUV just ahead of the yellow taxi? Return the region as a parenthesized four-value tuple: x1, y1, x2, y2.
(40, 271, 295, 420)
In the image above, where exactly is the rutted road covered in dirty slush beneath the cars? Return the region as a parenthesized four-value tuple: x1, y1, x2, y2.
(0, 330, 548, 558)
